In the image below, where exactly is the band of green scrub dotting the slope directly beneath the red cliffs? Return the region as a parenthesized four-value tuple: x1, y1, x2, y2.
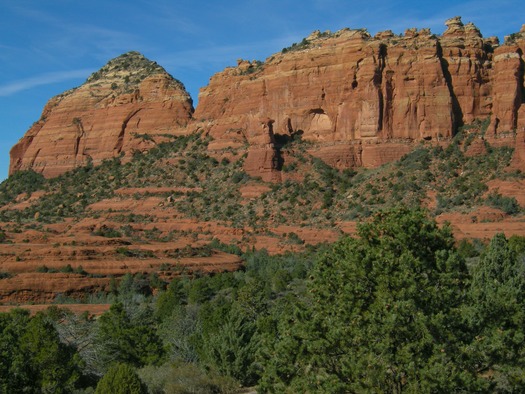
(0, 129, 524, 231)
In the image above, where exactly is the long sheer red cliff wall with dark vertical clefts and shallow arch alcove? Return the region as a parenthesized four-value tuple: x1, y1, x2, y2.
(195, 17, 525, 180)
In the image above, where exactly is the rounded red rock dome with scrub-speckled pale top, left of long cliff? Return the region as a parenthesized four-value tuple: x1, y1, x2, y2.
(10, 52, 193, 177)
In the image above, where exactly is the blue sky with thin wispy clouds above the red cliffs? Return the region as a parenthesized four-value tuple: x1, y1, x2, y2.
(0, 0, 525, 180)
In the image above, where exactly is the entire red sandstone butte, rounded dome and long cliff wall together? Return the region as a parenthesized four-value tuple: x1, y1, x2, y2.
(10, 17, 525, 181)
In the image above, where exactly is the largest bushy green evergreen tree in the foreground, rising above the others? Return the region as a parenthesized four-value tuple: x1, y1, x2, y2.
(261, 208, 478, 393)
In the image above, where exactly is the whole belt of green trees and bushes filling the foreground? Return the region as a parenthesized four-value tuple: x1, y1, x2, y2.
(0, 208, 525, 393)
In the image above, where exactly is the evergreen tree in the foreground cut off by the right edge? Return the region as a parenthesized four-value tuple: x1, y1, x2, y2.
(468, 234, 525, 392)
